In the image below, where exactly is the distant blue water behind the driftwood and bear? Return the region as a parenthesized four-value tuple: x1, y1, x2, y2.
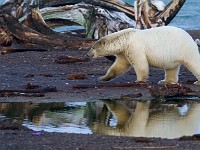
(0, 0, 200, 30)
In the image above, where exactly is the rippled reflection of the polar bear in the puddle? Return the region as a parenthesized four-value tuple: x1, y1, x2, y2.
(93, 101, 200, 138)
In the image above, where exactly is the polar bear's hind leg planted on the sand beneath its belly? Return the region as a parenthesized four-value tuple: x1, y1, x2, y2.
(158, 65, 180, 84)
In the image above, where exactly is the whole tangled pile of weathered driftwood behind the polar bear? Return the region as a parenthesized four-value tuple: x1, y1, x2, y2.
(0, 0, 185, 55)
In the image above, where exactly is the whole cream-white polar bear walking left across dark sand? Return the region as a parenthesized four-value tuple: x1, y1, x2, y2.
(87, 26, 200, 85)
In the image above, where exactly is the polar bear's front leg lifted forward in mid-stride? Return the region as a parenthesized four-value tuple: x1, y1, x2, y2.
(99, 54, 131, 81)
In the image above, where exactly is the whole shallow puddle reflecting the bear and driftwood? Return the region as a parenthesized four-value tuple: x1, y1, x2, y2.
(0, 100, 200, 138)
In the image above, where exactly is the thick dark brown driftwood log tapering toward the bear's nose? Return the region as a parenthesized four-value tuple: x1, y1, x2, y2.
(0, 14, 94, 54)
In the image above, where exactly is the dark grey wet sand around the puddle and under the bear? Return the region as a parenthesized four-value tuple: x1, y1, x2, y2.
(0, 31, 200, 150)
